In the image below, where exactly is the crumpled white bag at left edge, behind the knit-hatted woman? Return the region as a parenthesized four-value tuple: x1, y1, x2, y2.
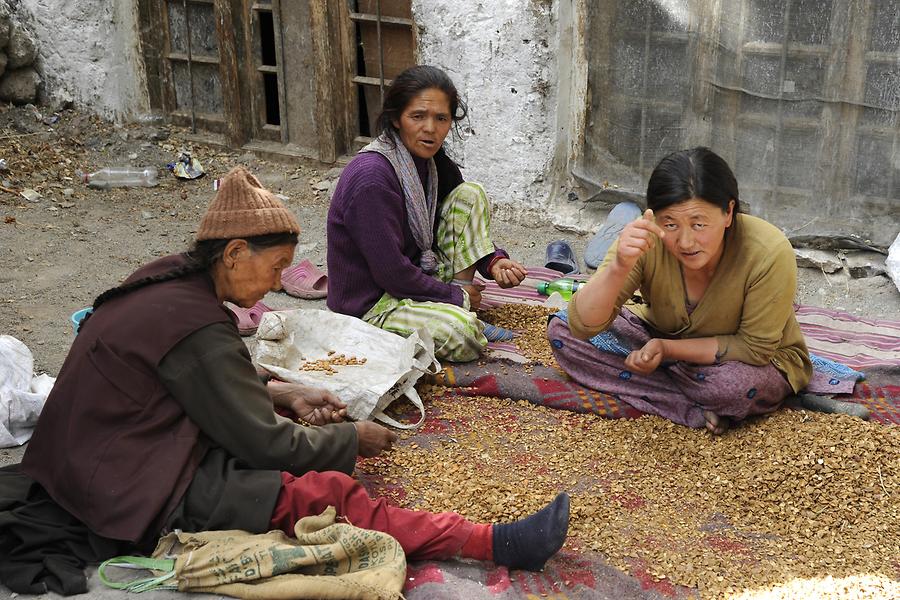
(0, 335, 56, 448)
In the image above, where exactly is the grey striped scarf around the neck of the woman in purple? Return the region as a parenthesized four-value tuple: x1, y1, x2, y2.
(360, 131, 438, 275)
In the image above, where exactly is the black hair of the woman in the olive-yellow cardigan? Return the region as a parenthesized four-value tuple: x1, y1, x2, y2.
(647, 146, 741, 223)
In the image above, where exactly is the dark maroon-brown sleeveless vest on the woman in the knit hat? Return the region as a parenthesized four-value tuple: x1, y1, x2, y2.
(22, 256, 231, 542)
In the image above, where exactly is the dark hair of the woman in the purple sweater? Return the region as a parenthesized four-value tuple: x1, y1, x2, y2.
(375, 65, 469, 141)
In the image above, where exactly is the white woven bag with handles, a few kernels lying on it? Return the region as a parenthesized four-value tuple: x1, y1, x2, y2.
(254, 309, 441, 429)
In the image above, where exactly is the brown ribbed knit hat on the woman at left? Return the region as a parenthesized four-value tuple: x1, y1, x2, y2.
(197, 167, 300, 242)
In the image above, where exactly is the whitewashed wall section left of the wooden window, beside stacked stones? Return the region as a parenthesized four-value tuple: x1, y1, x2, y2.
(19, 0, 147, 119)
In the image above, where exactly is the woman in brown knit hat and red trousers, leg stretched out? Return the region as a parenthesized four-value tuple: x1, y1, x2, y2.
(22, 168, 568, 569)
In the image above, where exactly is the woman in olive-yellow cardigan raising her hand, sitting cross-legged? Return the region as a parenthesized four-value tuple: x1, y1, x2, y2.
(548, 148, 812, 434)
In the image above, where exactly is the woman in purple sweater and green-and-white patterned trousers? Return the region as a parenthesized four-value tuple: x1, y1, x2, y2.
(328, 66, 526, 361)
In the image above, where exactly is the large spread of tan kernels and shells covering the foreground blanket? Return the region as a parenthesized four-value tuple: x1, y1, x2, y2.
(361, 387, 900, 599)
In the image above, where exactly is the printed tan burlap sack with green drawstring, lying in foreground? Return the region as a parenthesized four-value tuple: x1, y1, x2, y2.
(100, 506, 406, 600)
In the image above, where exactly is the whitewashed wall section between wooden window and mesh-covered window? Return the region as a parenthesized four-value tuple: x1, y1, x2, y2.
(413, 0, 559, 211)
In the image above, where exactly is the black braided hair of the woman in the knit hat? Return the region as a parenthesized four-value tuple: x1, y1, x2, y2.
(78, 233, 298, 331)
